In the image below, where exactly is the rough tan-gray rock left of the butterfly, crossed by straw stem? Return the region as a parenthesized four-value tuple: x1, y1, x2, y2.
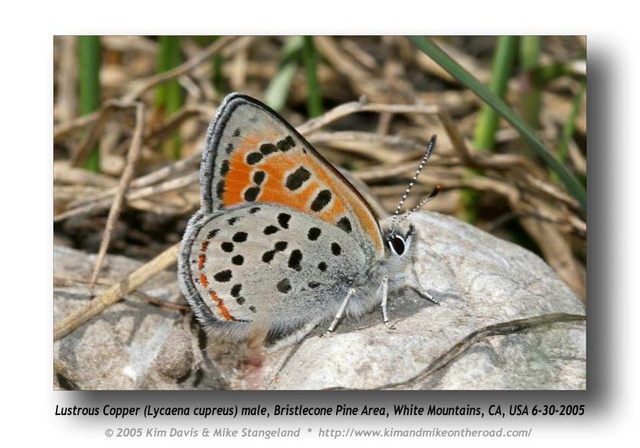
(53, 247, 220, 390)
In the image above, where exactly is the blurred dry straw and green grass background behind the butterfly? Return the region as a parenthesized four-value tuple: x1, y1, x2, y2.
(53, 36, 587, 300)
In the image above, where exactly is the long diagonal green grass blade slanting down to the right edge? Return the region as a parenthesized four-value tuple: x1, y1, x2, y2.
(408, 36, 587, 212)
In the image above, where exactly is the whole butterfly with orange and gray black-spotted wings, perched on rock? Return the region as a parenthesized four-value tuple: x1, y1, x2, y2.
(178, 93, 440, 338)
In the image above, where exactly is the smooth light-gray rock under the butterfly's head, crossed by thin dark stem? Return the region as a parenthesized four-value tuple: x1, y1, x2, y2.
(262, 213, 586, 390)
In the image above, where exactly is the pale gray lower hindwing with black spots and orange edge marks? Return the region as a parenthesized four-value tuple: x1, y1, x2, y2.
(179, 204, 365, 331)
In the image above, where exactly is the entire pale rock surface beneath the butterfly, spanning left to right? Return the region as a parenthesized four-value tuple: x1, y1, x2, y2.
(54, 213, 587, 390)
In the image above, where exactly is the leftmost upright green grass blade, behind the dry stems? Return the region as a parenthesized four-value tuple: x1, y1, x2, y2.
(78, 36, 102, 173)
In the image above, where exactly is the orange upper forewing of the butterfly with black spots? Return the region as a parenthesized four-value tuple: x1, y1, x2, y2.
(201, 94, 384, 258)
